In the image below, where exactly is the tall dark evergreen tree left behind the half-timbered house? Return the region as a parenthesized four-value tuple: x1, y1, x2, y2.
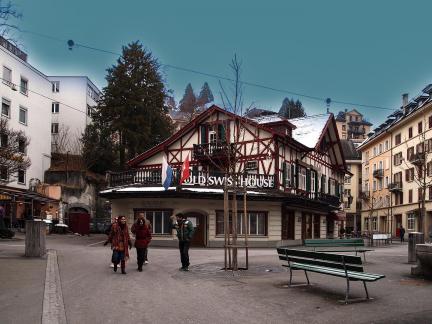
(83, 42, 172, 170)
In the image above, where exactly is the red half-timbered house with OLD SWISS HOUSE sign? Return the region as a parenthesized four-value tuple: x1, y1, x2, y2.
(100, 106, 347, 247)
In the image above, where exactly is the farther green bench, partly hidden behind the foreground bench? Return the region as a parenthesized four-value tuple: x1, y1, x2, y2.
(304, 238, 373, 261)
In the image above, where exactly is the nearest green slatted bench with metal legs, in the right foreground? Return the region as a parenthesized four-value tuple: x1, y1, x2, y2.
(277, 247, 385, 304)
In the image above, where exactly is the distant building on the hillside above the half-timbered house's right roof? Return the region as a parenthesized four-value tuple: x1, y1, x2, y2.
(336, 109, 372, 145)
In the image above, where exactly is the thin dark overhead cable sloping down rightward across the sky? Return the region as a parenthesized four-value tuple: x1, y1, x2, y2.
(22, 30, 396, 111)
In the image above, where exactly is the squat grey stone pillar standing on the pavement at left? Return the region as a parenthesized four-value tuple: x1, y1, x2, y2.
(25, 220, 46, 257)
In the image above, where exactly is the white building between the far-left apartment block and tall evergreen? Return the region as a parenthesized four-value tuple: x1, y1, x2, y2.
(48, 76, 101, 153)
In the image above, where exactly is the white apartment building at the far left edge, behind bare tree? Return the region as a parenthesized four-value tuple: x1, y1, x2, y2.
(0, 38, 51, 189)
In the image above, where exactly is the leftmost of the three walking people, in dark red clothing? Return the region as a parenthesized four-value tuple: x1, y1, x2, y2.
(104, 216, 132, 274)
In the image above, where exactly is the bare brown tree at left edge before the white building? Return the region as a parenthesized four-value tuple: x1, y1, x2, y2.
(0, 118, 31, 182)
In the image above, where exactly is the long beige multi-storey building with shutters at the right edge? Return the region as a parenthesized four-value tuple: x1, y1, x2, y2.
(359, 90, 432, 238)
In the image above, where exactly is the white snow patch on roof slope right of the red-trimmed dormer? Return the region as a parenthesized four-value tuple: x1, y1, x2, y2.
(289, 114, 330, 148)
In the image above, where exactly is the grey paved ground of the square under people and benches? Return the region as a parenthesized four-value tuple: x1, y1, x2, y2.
(0, 235, 432, 323)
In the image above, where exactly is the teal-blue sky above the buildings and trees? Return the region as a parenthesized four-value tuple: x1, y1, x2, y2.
(9, 0, 432, 124)
